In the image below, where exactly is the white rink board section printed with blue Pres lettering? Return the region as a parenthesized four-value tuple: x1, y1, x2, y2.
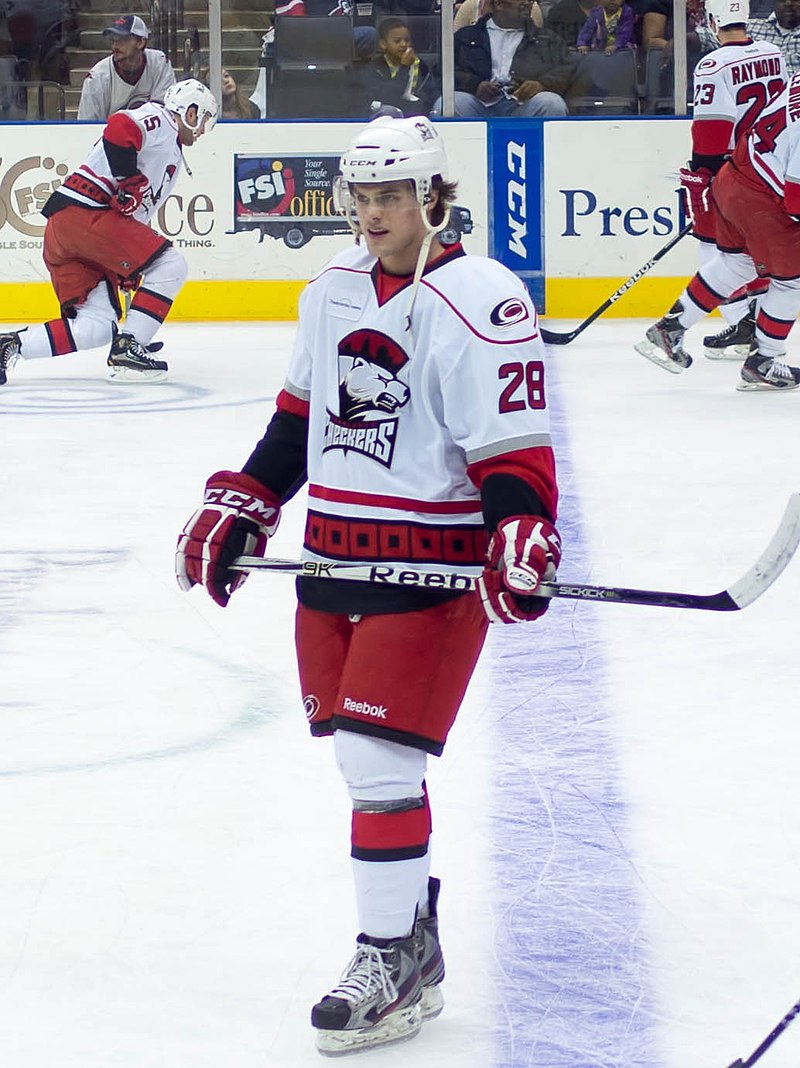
(544, 119, 697, 280)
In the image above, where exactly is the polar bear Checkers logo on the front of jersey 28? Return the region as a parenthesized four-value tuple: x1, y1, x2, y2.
(323, 329, 410, 467)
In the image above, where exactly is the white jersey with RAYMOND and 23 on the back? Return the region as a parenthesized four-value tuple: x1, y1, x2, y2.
(692, 41, 787, 156)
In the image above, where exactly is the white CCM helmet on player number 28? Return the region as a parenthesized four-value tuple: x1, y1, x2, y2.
(339, 115, 448, 205)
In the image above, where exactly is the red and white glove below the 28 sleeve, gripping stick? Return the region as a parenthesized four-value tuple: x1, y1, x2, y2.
(477, 516, 561, 623)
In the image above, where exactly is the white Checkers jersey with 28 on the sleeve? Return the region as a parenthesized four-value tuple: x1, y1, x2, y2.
(284, 247, 554, 569)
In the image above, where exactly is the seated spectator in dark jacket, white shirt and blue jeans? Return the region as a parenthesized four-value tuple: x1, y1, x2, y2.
(434, 0, 578, 119)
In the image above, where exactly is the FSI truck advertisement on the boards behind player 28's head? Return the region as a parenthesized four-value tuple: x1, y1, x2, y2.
(233, 154, 472, 249)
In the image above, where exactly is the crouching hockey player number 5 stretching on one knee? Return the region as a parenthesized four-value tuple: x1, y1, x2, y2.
(0, 79, 217, 386)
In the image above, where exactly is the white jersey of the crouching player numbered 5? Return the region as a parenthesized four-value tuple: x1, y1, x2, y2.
(59, 104, 183, 222)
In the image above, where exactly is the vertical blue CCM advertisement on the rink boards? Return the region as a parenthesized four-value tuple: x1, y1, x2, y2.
(487, 125, 545, 309)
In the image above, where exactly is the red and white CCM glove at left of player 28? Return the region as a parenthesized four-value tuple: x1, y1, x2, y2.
(175, 471, 281, 608)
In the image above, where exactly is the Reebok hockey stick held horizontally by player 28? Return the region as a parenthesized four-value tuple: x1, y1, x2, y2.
(233, 493, 800, 612)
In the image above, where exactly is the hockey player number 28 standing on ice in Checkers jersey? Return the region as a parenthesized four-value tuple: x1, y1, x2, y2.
(176, 117, 561, 1054)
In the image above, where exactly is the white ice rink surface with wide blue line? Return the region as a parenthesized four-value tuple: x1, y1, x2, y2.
(0, 320, 800, 1068)
